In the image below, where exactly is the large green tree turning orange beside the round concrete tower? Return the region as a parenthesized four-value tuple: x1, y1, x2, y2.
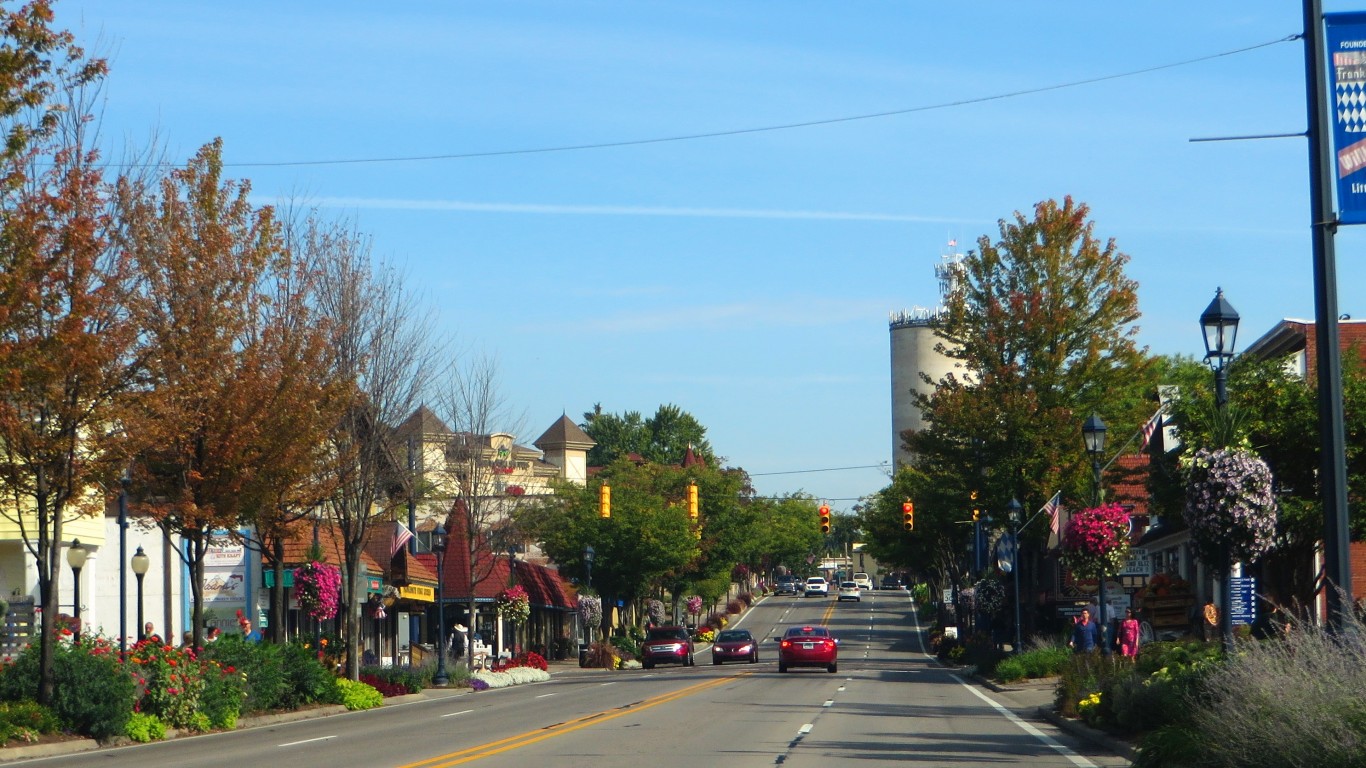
(906, 198, 1154, 549)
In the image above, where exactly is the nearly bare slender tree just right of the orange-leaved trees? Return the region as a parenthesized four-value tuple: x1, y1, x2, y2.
(318, 226, 432, 679)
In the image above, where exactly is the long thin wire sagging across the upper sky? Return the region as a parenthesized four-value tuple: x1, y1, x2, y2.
(215, 33, 1302, 168)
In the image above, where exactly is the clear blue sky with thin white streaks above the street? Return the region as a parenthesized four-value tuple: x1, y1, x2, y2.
(48, 0, 1366, 512)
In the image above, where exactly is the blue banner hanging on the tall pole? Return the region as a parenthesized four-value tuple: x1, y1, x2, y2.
(1324, 12, 1366, 224)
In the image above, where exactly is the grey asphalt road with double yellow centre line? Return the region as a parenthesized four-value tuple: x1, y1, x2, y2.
(14, 592, 1128, 768)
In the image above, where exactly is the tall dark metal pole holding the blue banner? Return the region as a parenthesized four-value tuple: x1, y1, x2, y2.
(1305, 0, 1352, 629)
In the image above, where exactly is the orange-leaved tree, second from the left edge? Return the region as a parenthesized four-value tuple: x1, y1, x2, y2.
(119, 141, 294, 642)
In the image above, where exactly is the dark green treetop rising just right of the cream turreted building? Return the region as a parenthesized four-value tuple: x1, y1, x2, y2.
(579, 404, 717, 466)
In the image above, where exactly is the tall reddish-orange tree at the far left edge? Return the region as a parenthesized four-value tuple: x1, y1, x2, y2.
(0, 1, 120, 704)
